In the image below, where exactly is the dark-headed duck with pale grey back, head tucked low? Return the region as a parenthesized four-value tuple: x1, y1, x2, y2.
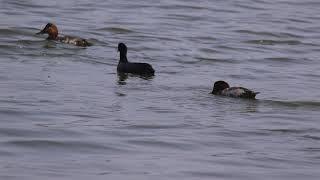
(211, 81, 259, 99)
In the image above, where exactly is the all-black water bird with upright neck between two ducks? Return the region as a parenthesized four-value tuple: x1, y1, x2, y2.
(117, 43, 154, 76)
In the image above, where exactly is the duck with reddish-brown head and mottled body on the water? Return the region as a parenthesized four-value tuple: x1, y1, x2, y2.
(37, 23, 91, 47)
